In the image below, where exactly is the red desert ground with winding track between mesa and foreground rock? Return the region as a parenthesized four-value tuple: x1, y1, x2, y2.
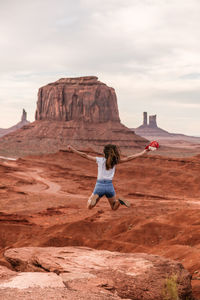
(0, 147, 200, 299)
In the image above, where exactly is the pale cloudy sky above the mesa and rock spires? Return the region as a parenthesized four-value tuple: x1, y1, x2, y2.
(0, 0, 200, 136)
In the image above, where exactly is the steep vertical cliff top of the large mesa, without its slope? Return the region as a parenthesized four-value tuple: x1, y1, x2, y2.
(35, 76, 120, 123)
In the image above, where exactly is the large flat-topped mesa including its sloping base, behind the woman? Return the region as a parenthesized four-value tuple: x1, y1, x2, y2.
(0, 76, 148, 156)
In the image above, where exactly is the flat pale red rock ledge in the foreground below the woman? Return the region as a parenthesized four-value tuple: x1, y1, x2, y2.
(0, 247, 193, 300)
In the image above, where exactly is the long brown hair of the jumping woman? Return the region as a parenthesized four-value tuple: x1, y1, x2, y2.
(103, 144, 120, 170)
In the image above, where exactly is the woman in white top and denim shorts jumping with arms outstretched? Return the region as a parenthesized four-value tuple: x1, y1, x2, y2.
(68, 141, 159, 210)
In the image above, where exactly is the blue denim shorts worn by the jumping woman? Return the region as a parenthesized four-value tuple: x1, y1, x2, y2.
(93, 180, 115, 198)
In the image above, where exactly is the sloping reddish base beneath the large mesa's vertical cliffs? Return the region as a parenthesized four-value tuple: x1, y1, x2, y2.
(0, 121, 145, 157)
